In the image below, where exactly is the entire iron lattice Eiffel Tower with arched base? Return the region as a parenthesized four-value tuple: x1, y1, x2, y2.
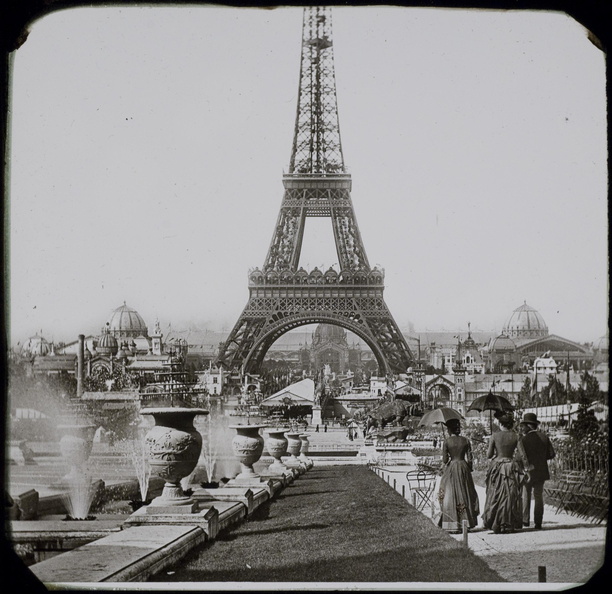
(217, 7, 413, 375)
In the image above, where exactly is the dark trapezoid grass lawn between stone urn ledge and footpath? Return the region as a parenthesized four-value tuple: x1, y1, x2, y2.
(151, 465, 504, 582)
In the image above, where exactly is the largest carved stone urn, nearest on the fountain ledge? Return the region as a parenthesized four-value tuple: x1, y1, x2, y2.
(140, 407, 208, 512)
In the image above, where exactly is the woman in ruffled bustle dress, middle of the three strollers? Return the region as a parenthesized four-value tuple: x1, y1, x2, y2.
(482, 413, 524, 534)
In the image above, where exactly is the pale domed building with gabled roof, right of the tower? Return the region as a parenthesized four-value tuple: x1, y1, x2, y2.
(486, 301, 593, 373)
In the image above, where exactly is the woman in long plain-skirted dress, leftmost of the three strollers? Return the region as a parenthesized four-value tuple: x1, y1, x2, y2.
(438, 419, 480, 532)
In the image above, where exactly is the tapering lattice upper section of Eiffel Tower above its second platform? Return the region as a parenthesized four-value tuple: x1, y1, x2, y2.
(289, 6, 345, 175)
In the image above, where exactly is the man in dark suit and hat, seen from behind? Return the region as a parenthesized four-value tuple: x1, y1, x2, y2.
(520, 413, 555, 530)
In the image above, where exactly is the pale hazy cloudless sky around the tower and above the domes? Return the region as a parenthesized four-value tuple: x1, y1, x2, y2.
(8, 6, 608, 341)
